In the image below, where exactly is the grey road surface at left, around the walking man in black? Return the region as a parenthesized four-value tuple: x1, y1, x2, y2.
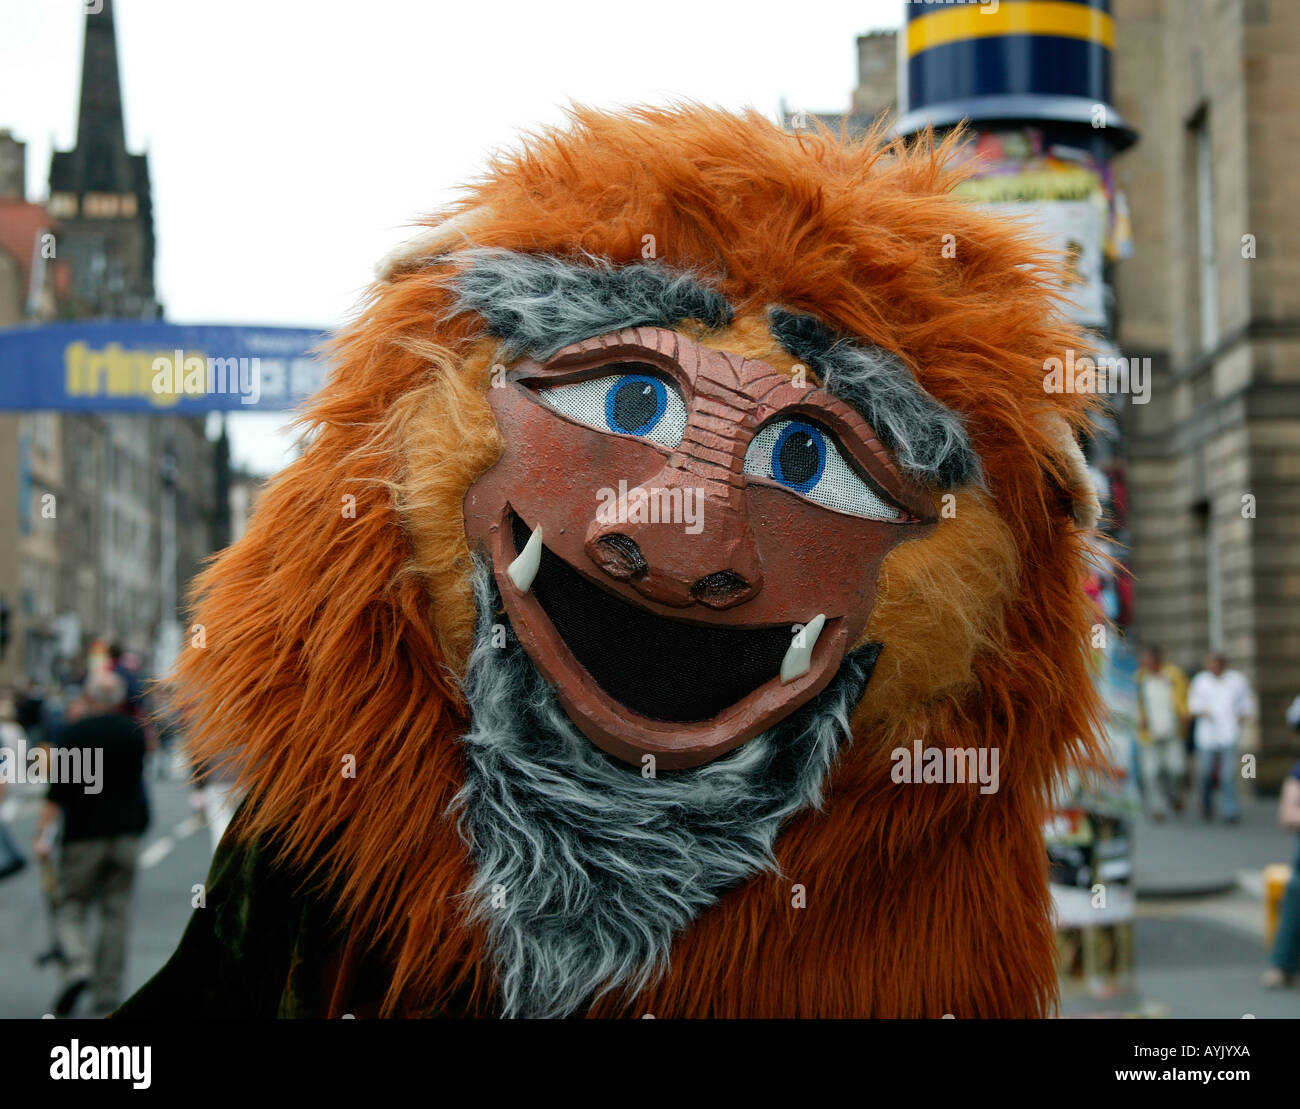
(0, 764, 211, 1018)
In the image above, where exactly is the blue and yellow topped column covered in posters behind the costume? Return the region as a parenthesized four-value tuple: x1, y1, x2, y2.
(896, 0, 1139, 1014)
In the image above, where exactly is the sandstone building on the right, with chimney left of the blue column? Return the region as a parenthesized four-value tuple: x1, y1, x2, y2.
(790, 0, 1300, 789)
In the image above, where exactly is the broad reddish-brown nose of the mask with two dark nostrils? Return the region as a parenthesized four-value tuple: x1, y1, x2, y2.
(586, 454, 763, 608)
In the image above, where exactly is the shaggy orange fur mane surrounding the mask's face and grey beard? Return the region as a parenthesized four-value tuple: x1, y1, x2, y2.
(172, 107, 1099, 1017)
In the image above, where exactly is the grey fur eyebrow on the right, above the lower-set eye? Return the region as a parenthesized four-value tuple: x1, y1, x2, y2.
(767, 307, 983, 489)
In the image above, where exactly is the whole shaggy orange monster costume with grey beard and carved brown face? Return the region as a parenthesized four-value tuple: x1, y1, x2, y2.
(121, 107, 1099, 1017)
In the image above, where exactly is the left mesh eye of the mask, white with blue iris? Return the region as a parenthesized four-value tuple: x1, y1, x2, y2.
(537, 373, 686, 447)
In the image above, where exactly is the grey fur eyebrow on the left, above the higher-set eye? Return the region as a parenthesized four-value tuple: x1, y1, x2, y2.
(450, 247, 735, 360)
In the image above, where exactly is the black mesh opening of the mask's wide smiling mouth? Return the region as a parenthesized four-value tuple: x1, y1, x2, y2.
(510, 512, 793, 724)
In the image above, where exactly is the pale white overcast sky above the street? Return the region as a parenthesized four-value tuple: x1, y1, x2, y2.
(0, 0, 902, 473)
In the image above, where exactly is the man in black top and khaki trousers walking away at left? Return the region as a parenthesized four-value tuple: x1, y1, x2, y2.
(34, 671, 150, 1017)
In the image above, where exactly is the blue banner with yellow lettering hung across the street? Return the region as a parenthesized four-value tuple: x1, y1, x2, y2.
(0, 321, 329, 415)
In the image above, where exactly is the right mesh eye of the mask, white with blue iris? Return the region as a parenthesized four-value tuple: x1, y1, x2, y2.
(745, 420, 905, 520)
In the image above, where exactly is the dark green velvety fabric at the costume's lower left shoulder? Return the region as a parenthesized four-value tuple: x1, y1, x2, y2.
(113, 811, 342, 1019)
